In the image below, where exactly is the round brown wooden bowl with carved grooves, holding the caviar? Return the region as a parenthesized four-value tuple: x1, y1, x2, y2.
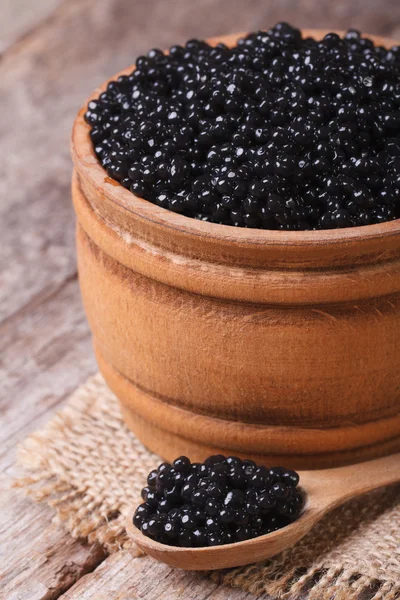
(72, 32, 400, 469)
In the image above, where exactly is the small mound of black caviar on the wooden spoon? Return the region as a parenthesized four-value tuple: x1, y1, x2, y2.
(133, 454, 303, 547)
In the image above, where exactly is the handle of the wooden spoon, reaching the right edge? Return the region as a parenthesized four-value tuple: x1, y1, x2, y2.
(301, 454, 400, 511)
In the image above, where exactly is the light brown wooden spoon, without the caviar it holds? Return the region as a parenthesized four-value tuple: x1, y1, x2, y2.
(127, 454, 400, 571)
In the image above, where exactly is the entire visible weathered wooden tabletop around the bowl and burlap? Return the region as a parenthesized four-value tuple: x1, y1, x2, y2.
(0, 0, 400, 600)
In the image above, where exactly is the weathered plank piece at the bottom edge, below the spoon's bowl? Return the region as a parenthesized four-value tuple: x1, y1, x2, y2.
(60, 550, 255, 600)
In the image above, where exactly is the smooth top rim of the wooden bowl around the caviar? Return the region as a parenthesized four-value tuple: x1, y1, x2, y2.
(71, 29, 400, 247)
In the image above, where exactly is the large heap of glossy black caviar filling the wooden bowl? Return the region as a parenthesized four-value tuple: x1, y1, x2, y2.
(85, 23, 400, 230)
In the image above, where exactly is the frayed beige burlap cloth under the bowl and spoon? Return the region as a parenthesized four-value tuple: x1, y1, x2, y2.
(16, 375, 400, 600)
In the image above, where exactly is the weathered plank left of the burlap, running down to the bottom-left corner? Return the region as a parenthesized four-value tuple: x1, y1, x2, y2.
(0, 277, 98, 600)
